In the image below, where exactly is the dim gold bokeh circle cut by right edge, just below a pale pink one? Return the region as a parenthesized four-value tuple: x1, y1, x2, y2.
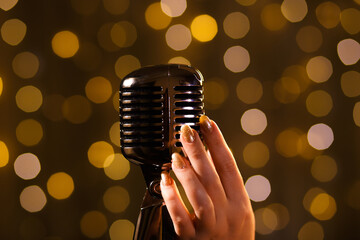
(340, 71, 360, 97)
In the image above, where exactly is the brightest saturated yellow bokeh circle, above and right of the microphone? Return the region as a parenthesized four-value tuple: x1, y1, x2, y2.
(190, 14, 218, 42)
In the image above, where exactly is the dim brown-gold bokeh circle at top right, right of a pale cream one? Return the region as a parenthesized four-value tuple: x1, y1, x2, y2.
(315, 1, 341, 29)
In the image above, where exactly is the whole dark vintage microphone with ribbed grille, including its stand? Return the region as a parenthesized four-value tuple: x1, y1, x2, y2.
(119, 64, 204, 240)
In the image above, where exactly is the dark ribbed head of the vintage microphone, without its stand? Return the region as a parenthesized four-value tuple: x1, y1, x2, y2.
(119, 64, 204, 167)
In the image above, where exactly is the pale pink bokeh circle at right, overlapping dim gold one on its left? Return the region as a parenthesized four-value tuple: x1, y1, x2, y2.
(307, 123, 334, 150)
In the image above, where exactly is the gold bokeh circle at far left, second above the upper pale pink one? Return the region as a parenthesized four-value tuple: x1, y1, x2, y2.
(15, 85, 43, 113)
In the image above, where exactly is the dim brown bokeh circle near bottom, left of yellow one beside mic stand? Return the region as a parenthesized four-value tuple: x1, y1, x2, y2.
(103, 186, 130, 213)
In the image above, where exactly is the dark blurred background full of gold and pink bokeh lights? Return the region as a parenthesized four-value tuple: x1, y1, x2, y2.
(0, 0, 360, 240)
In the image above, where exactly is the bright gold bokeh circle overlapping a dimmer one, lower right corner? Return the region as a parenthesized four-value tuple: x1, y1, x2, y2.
(310, 193, 336, 221)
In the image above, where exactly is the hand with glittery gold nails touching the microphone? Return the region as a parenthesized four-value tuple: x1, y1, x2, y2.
(161, 116, 255, 240)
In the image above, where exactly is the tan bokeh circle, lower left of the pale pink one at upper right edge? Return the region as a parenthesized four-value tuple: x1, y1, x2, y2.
(306, 56, 333, 83)
